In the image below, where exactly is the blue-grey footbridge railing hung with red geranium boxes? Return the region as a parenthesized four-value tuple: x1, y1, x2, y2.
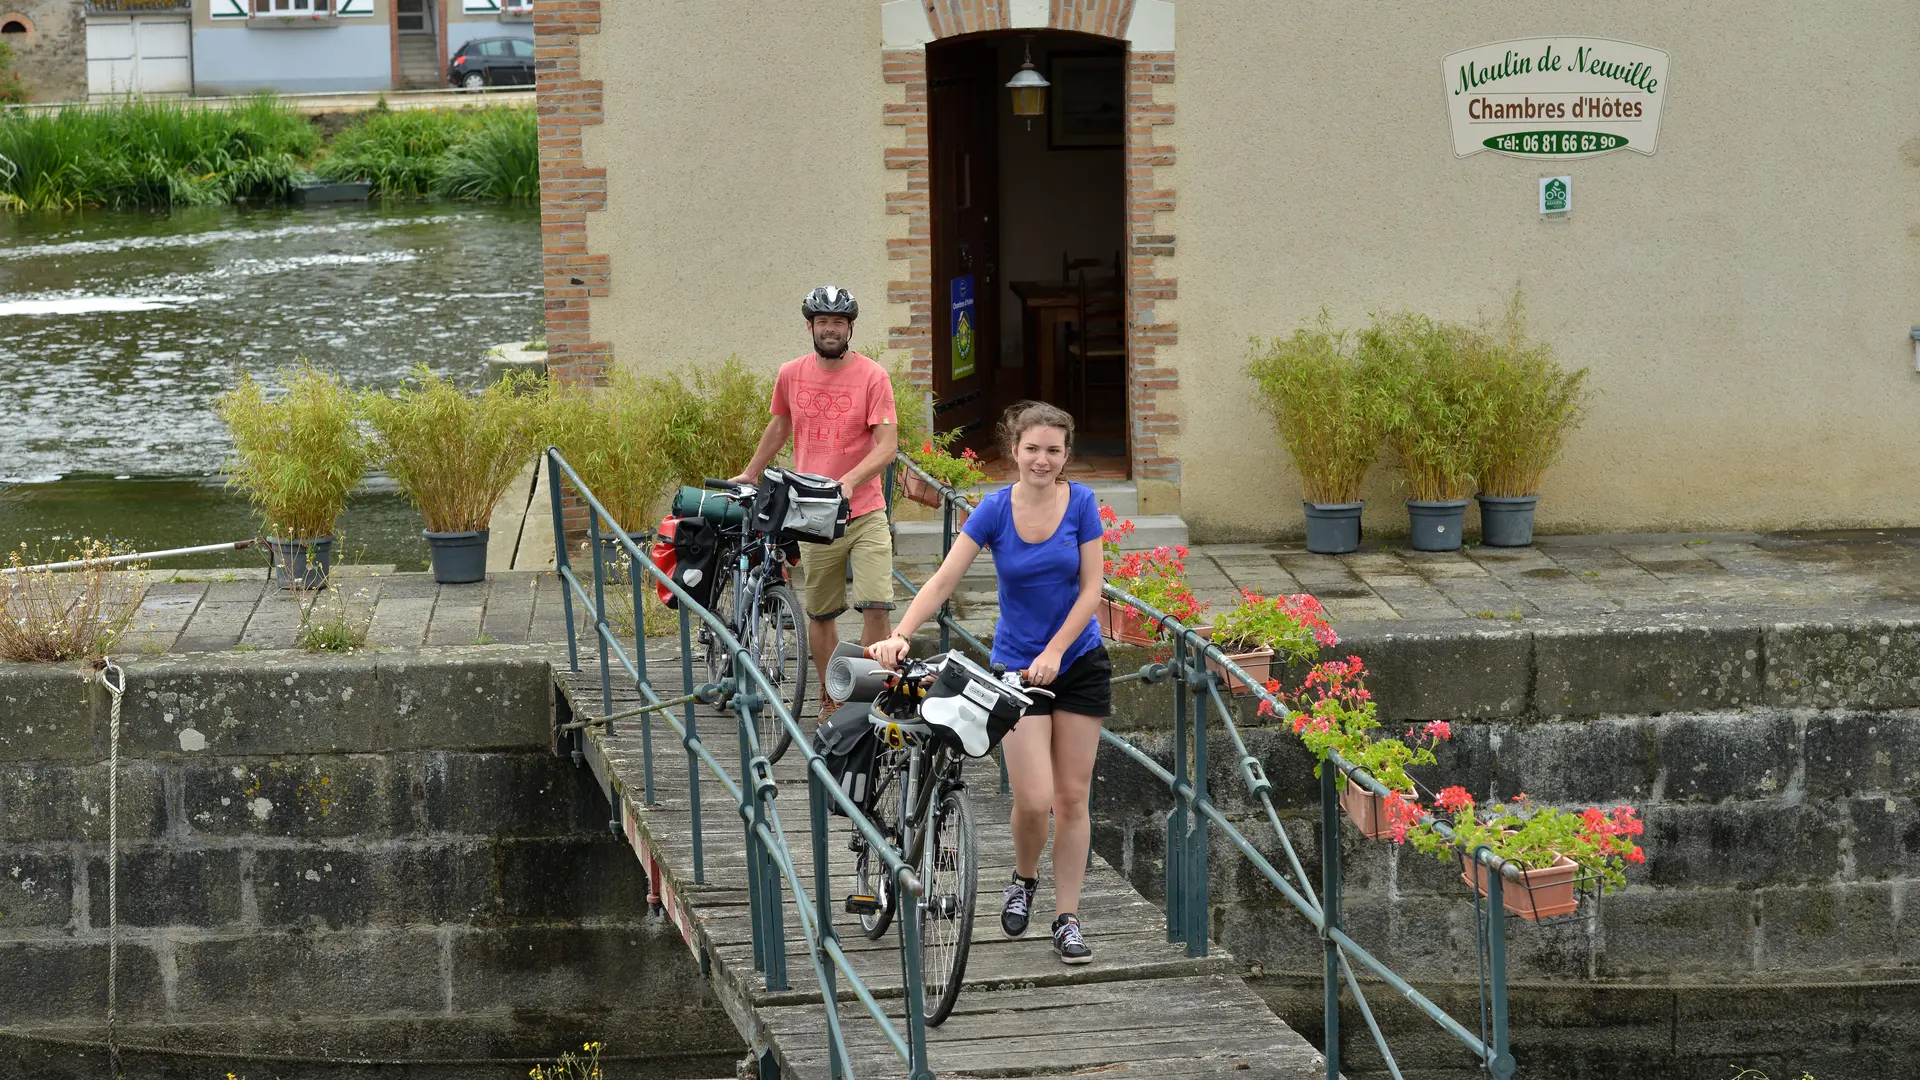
(887, 454, 1521, 1080)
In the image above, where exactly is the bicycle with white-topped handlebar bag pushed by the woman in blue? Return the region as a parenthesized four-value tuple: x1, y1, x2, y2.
(828, 651, 1052, 1026)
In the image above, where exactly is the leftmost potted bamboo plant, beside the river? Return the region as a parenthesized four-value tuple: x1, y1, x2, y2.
(215, 363, 367, 588)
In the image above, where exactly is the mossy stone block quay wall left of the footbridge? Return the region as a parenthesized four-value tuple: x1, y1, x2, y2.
(0, 648, 739, 1076)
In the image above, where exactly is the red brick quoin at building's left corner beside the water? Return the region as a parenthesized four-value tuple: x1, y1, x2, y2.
(534, 0, 612, 393)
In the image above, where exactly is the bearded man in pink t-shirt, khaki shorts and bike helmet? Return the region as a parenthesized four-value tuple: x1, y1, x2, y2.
(733, 284, 900, 721)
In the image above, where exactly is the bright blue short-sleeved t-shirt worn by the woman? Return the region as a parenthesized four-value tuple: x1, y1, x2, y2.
(962, 482, 1102, 671)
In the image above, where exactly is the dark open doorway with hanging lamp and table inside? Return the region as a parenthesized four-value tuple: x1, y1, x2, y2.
(927, 33, 1129, 479)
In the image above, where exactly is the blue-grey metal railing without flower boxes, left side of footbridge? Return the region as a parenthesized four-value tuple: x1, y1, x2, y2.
(545, 448, 933, 1080)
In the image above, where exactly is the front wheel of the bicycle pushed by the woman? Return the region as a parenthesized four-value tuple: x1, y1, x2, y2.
(920, 776, 979, 1028)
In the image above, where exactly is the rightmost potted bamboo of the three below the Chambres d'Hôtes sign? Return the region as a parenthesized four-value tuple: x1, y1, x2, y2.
(1475, 296, 1590, 548)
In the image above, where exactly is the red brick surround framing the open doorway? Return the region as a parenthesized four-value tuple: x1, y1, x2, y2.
(881, 0, 1181, 484)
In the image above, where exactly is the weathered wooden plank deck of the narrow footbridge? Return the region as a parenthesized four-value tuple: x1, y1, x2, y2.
(555, 642, 1325, 1080)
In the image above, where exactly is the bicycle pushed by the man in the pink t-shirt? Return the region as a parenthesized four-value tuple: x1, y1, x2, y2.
(695, 477, 810, 761)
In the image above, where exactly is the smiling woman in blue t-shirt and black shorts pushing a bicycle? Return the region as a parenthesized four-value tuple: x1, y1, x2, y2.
(868, 402, 1114, 965)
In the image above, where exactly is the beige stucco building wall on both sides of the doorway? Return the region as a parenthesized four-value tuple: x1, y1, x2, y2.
(541, 0, 1920, 538)
